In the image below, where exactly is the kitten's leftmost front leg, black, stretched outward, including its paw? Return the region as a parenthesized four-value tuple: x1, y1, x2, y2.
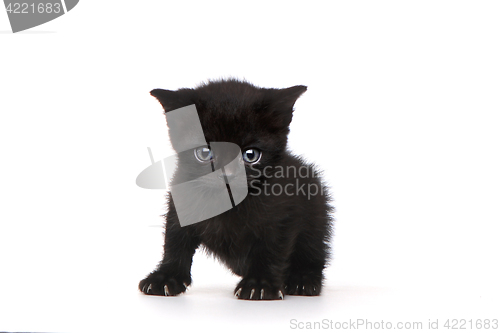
(139, 204, 200, 296)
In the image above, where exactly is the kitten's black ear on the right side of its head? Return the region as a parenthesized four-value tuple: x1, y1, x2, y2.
(263, 86, 307, 130)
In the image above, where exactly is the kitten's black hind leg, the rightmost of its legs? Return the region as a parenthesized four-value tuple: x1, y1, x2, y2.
(285, 233, 327, 296)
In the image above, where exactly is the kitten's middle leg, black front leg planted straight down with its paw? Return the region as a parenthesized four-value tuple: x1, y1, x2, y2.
(234, 243, 286, 300)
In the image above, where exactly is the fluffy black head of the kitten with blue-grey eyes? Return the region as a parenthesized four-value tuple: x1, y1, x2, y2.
(151, 79, 307, 202)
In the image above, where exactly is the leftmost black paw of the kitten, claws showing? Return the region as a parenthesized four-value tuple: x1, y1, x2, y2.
(139, 271, 191, 296)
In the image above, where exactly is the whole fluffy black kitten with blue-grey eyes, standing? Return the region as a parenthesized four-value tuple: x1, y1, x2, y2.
(139, 79, 333, 300)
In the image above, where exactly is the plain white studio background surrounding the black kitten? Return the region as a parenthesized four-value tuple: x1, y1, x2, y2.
(0, 0, 500, 332)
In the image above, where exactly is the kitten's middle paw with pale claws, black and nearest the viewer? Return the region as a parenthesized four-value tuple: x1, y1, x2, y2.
(234, 279, 284, 300)
